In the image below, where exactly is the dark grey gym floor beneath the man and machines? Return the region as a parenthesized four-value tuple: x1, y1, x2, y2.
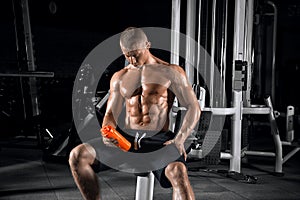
(0, 134, 300, 200)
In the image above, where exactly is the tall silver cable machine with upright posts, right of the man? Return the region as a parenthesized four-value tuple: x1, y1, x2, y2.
(171, 0, 299, 175)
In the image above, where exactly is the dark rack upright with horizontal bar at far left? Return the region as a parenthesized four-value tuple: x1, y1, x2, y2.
(0, 0, 54, 148)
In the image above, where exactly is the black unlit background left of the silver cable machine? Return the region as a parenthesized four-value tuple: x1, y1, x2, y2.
(0, 0, 171, 140)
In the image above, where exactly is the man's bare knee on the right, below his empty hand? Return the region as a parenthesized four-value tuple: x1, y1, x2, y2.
(165, 162, 187, 181)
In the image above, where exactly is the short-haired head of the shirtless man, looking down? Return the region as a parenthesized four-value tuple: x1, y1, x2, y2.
(120, 27, 150, 66)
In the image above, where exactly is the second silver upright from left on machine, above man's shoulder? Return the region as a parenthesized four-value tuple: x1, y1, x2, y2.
(185, 0, 196, 84)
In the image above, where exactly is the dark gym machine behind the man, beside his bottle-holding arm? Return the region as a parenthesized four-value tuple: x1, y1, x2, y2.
(43, 64, 109, 161)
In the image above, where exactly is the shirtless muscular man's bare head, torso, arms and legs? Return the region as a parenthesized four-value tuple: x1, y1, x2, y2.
(69, 27, 201, 200)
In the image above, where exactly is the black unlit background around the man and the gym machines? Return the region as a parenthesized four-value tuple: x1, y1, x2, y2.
(0, 0, 300, 144)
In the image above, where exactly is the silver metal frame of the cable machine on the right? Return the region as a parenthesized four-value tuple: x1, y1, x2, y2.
(171, 0, 300, 173)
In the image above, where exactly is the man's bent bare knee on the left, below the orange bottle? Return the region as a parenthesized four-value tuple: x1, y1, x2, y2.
(69, 144, 96, 167)
